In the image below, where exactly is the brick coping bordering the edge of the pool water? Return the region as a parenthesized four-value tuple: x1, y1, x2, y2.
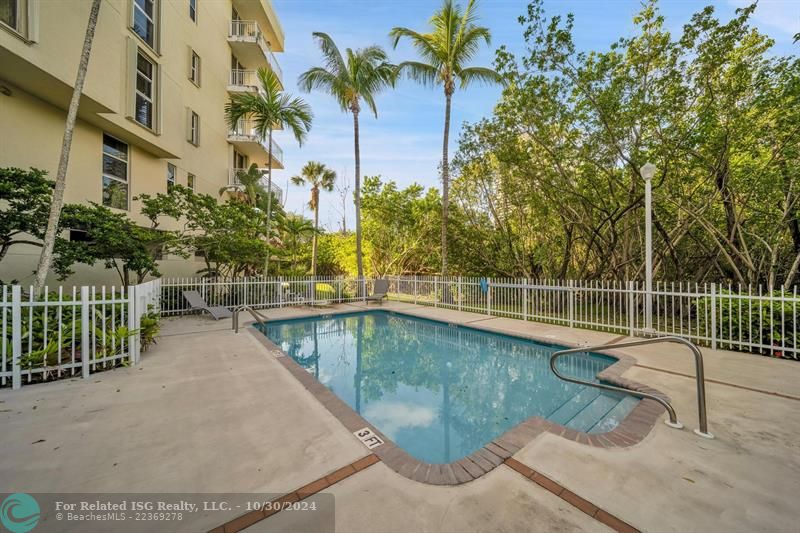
(247, 310, 668, 485)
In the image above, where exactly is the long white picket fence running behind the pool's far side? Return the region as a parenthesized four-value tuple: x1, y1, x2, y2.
(162, 276, 800, 359)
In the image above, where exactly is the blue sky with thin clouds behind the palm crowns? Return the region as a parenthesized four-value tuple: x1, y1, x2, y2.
(272, 0, 800, 230)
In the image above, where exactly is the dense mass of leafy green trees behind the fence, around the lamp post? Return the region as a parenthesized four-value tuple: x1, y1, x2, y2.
(453, 0, 800, 286)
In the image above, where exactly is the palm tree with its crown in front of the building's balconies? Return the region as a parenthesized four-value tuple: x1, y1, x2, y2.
(225, 67, 313, 276)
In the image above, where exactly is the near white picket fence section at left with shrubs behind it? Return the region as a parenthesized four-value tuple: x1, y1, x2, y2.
(0, 279, 161, 389)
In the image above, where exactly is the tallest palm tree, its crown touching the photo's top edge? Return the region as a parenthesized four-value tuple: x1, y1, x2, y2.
(389, 0, 500, 276)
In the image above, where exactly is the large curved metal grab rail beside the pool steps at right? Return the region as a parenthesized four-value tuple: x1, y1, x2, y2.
(550, 336, 714, 439)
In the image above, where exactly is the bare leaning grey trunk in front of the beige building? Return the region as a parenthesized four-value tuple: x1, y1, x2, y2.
(34, 0, 101, 293)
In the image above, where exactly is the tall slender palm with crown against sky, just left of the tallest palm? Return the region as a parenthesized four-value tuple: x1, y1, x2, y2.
(298, 32, 395, 279)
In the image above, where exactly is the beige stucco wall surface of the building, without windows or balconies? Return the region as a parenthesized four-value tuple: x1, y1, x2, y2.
(0, 0, 283, 286)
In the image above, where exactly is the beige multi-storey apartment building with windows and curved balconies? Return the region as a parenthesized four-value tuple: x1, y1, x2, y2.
(0, 0, 284, 281)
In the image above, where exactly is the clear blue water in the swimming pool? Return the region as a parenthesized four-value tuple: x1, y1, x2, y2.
(262, 311, 638, 463)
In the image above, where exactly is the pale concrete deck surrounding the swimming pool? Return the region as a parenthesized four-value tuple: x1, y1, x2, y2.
(0, 302, 800, 532)
